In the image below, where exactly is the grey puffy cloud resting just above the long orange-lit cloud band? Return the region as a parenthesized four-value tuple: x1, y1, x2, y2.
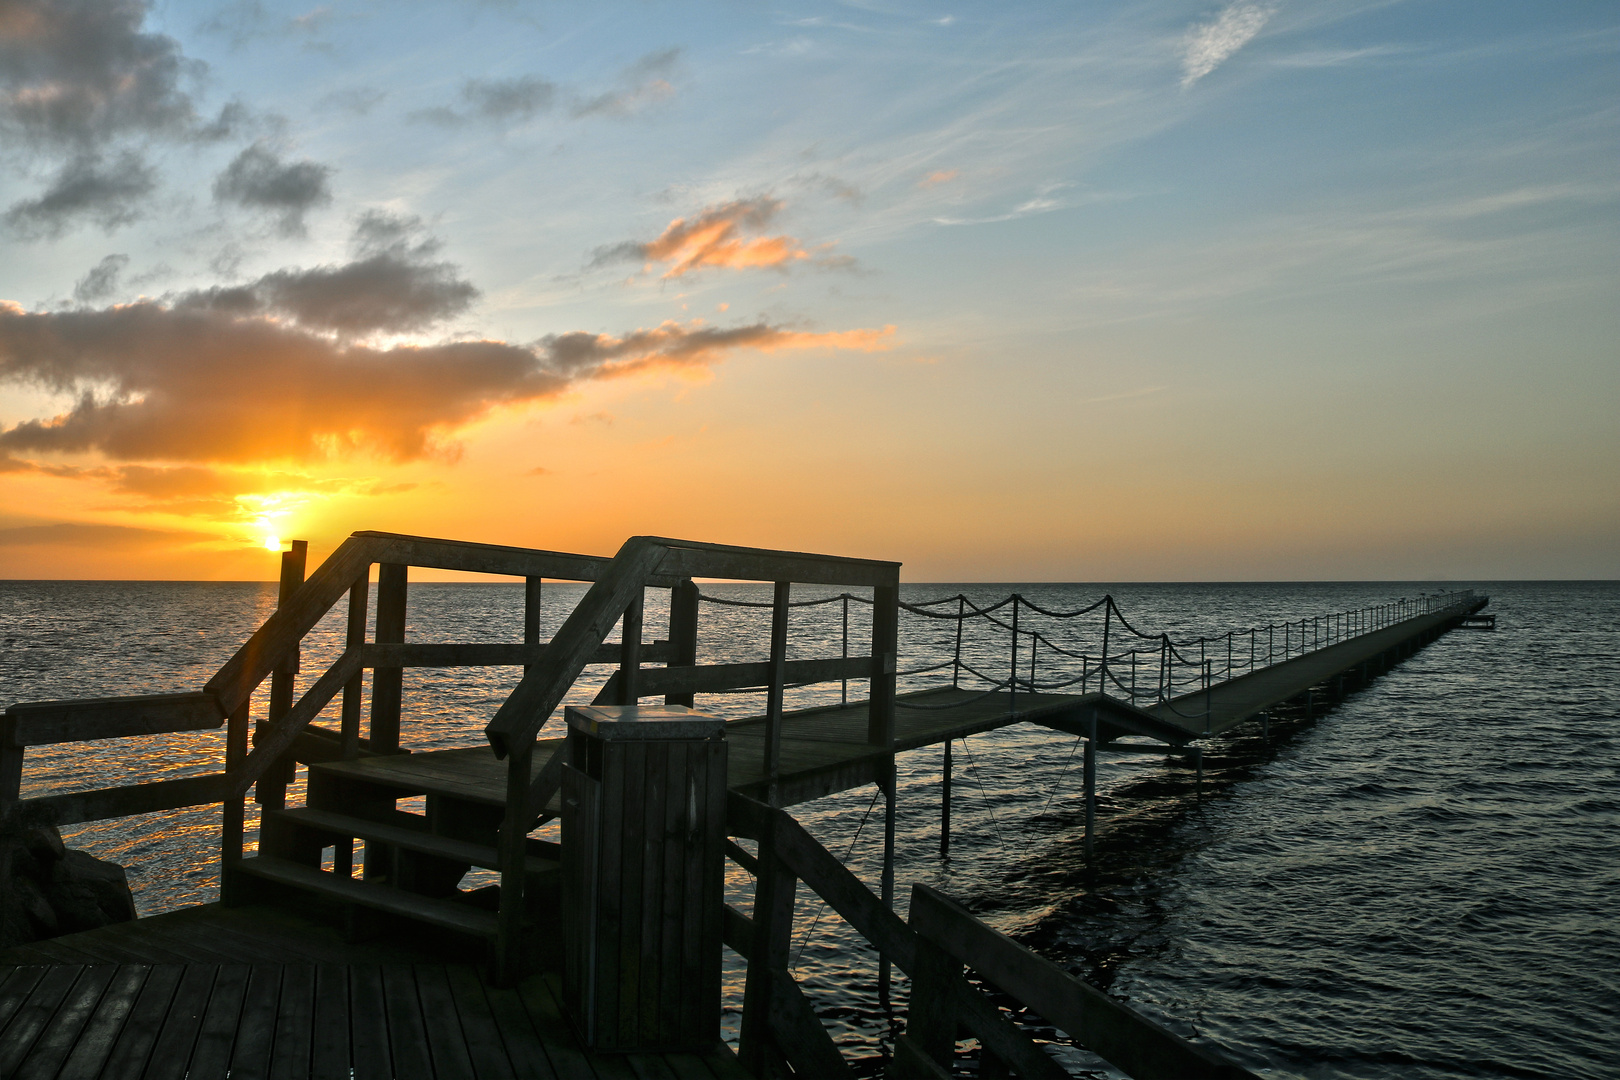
(173, 210, 478, 337)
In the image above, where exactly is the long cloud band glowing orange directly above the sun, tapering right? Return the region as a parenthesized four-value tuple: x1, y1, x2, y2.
(0, 301, 893, 463)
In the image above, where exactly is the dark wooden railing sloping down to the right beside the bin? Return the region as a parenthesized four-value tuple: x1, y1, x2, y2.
(724, 793, 1252, 1080)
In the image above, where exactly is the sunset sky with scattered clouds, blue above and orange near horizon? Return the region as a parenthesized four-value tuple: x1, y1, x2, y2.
(0, 0, 1620, 581)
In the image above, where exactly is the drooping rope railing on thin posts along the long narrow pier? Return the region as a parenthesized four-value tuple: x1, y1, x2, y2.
(700, 591, 1474, 719)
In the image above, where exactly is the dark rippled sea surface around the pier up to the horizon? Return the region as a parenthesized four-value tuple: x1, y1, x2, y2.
(0, 581, 1620, 1078)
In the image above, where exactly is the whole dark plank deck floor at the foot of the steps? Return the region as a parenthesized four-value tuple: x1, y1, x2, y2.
(0, 904, 750, 1080)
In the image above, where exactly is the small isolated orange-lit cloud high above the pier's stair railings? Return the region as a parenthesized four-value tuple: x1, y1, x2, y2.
(591, 196, 854, 279)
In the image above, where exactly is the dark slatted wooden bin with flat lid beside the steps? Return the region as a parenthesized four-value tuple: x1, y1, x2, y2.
(562, 706, 726, 1051)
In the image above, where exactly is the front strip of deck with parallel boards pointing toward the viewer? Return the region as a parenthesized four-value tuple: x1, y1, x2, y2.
(0, 962, 748, 1080)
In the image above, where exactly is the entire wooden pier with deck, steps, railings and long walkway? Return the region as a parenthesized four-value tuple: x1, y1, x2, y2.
(0, 533, 1487, 1078)
